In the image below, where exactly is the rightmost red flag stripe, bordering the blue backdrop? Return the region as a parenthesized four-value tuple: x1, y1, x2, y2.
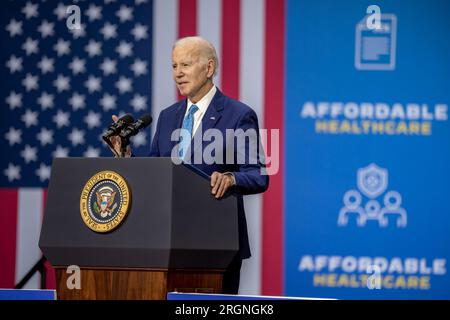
(262, 0, 285, 295)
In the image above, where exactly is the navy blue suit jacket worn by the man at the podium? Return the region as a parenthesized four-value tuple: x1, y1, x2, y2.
(150, 89, 269, 259)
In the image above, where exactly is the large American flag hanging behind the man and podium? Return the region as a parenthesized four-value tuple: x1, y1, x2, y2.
(0, 0, 285, 294)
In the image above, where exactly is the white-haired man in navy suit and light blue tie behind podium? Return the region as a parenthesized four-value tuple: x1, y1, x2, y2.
(112, 37, 269, 294)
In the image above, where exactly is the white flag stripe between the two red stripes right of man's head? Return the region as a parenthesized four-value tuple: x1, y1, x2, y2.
(239, 0, 264, 295)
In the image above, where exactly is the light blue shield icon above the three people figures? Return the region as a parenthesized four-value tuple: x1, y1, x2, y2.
(358, 163, 388, 199)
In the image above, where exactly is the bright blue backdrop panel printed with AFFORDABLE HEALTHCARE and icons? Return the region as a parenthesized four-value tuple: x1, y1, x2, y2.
(285, 0, 450, 299)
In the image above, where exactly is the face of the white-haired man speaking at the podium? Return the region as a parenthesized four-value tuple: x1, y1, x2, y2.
(172, 45, 212, 98)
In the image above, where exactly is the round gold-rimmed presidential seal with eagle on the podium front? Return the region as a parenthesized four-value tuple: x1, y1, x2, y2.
(80, 171, 131, 232)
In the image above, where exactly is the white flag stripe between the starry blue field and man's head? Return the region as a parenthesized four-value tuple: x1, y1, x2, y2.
(152, 0, 178, 137)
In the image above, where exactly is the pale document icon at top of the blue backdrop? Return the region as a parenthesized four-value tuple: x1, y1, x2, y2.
(355, 14, 397, 70)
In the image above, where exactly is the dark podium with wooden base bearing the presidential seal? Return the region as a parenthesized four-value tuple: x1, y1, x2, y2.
(39, 158, 239, 299)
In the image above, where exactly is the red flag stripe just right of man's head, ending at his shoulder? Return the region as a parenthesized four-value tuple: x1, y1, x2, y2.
(221, 0, 241, 99)
